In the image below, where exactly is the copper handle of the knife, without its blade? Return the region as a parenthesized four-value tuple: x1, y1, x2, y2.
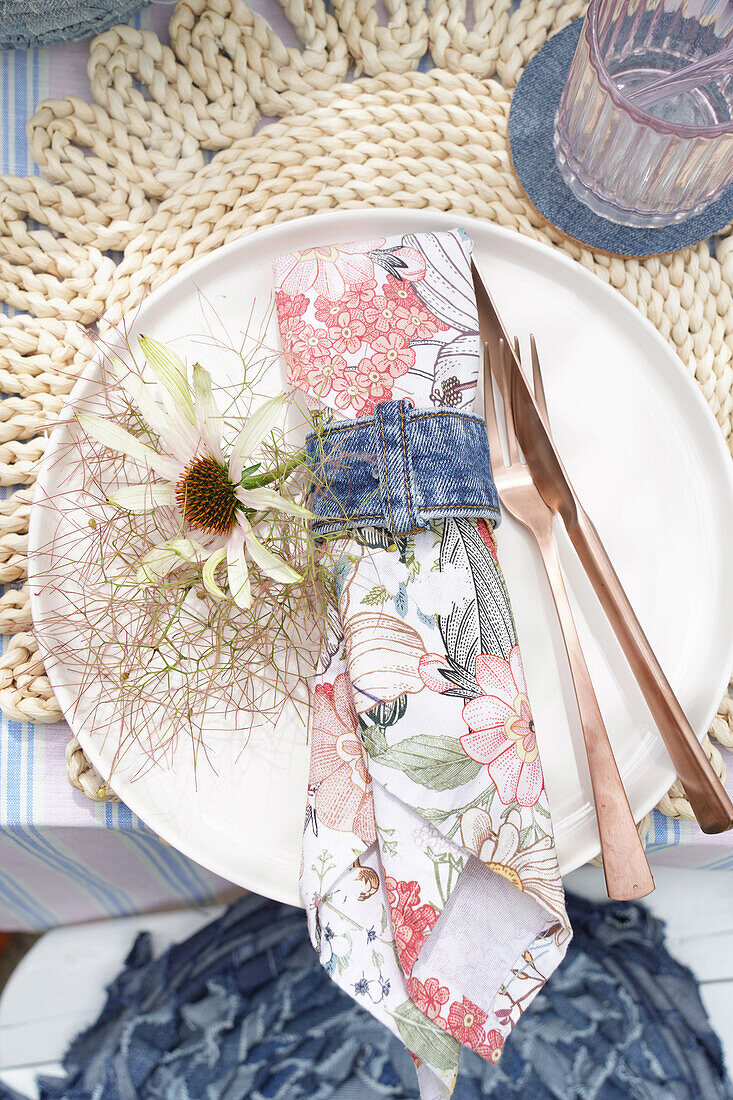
(566, 507, 733, 833)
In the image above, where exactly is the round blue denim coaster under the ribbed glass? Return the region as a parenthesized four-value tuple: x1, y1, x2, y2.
(508, 19, 733, 256)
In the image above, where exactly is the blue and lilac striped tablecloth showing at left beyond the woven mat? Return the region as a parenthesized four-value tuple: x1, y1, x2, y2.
(0, 4, 239, 930)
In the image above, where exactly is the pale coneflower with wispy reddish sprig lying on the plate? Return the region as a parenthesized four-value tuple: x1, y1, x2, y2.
(31, 321, 335, 783)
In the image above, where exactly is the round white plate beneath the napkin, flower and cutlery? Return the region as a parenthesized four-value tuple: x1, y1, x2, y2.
(29, 210, 733, 903)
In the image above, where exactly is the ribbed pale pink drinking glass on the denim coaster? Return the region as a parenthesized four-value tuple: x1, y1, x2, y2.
(555, 0, 733, 227)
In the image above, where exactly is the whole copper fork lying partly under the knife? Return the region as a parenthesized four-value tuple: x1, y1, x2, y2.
(483, 341, 654, 901)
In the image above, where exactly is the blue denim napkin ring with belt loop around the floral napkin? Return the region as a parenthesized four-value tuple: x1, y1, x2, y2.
(306, 400, 501, 536)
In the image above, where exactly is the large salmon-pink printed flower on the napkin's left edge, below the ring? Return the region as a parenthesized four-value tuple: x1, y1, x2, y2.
(310, 672, 376, 844)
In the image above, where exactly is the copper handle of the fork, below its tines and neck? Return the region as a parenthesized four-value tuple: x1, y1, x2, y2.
(537, 531, 654, 901)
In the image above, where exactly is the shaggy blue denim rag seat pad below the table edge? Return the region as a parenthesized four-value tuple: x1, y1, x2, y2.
(0, 897, 733, 1100)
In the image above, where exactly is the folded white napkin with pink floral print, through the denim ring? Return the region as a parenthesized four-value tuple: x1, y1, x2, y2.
(274, 230, 570, 1100)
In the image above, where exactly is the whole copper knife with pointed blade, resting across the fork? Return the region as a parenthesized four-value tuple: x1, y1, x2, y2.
(473, 261, 733, 833)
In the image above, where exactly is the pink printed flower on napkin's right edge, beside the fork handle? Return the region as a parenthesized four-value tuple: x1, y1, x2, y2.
(460, 646, 544, 806)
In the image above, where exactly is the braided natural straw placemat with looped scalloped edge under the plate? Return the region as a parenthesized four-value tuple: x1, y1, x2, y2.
(0, 0, 733, 817)
